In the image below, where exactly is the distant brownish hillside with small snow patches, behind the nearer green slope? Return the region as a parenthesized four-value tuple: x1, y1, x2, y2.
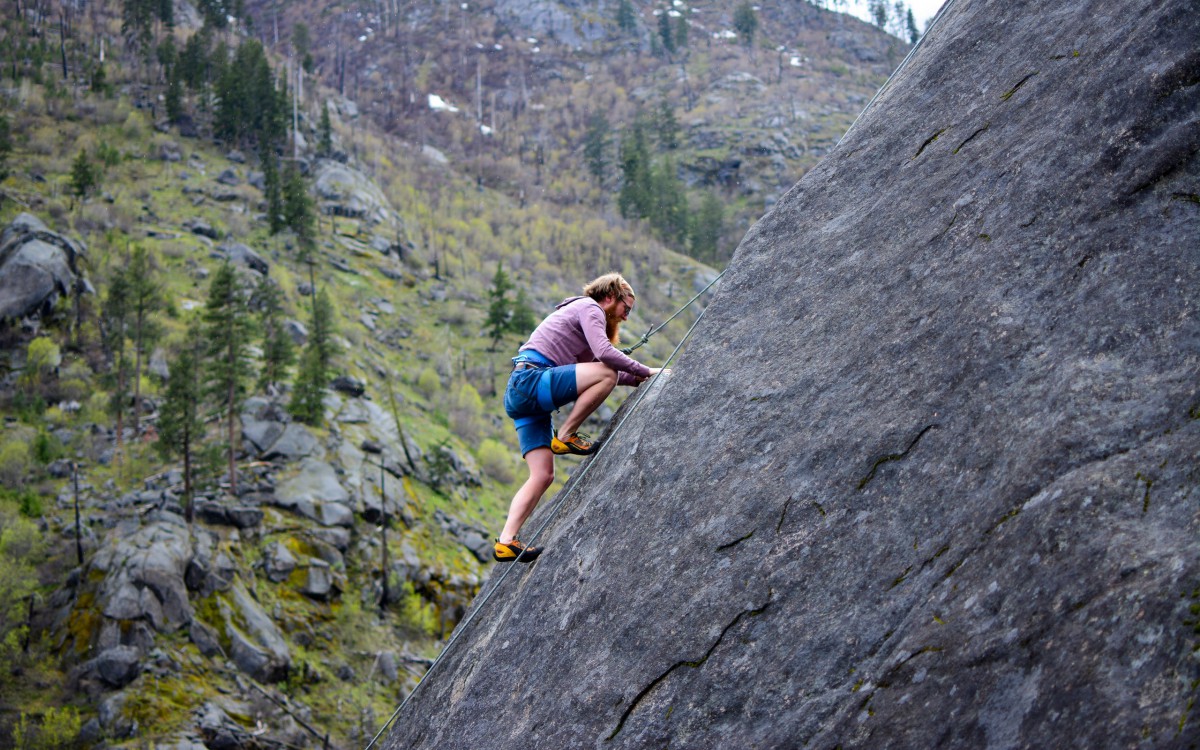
(238, 0, 908, 264)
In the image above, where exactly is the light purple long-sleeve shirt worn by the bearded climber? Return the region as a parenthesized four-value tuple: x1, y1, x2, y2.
(521, 296, 650, 385)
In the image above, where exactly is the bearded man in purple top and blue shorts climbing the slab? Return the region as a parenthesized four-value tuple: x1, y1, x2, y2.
(492, 274, 661, 563)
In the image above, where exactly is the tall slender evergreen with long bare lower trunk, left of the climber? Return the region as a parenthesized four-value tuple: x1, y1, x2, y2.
(203, 262, 253, 496)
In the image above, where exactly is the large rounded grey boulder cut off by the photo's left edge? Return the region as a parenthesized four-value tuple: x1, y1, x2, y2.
(0, 214, 84, 319)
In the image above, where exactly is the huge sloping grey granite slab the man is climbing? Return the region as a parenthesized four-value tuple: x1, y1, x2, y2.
(385, 0, 1200, 750)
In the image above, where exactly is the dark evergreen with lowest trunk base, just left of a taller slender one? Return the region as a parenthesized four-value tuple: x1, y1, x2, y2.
(157, 323, 204, 523)
